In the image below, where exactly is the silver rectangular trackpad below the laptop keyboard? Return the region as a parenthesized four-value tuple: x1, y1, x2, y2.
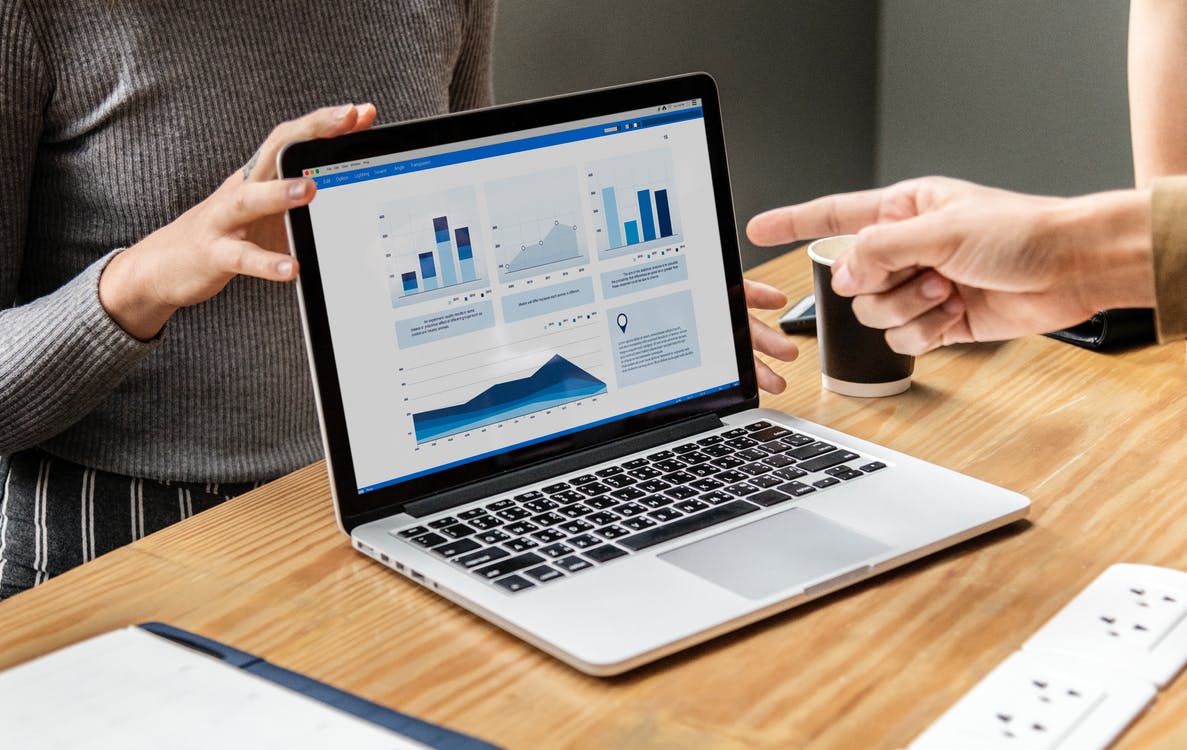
(659, 508, 890, 599)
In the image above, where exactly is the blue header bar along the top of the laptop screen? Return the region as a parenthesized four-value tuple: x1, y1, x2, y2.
(313, 107, 705, 190)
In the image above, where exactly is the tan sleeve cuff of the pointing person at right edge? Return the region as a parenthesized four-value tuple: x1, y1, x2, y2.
(1150, 176, 1187, 343)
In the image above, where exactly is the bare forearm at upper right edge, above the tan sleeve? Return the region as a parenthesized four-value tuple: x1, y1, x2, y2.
(1129, 0, 1187, 188)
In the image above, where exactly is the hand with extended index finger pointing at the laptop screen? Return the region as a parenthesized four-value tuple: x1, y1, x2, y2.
(747, 177, 1154, 354)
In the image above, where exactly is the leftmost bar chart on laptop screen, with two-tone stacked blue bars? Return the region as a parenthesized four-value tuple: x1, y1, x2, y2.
(376, 188, 488, 307)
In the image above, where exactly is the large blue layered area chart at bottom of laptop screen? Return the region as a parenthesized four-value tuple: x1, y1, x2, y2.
(401, 316, 609, 445)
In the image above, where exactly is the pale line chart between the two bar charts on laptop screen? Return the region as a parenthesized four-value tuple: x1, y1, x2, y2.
(485, 166, 589, 282)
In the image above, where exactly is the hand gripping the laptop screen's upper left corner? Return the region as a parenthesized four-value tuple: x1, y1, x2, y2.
(99, 104, 376, 341)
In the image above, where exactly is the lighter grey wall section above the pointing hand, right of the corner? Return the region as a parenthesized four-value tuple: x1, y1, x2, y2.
(876, 0, 1134, 195)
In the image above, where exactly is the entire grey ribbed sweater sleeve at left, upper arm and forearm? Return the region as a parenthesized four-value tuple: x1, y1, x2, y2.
(0, 0, 154, 455)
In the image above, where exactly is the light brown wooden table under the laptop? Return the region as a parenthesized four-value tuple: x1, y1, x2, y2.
(0, 252, 1187, 749)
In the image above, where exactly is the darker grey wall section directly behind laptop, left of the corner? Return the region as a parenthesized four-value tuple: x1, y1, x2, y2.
(486, 0, 877, 266)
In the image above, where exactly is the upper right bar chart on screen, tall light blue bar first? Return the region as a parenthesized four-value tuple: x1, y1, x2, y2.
(585, 148, 683, 258)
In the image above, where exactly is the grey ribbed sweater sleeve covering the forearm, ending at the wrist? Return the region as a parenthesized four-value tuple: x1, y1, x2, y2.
(0, 251, 154, 455)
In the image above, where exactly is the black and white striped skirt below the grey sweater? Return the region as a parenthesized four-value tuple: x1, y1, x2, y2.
(0, 449, 261, 599)
